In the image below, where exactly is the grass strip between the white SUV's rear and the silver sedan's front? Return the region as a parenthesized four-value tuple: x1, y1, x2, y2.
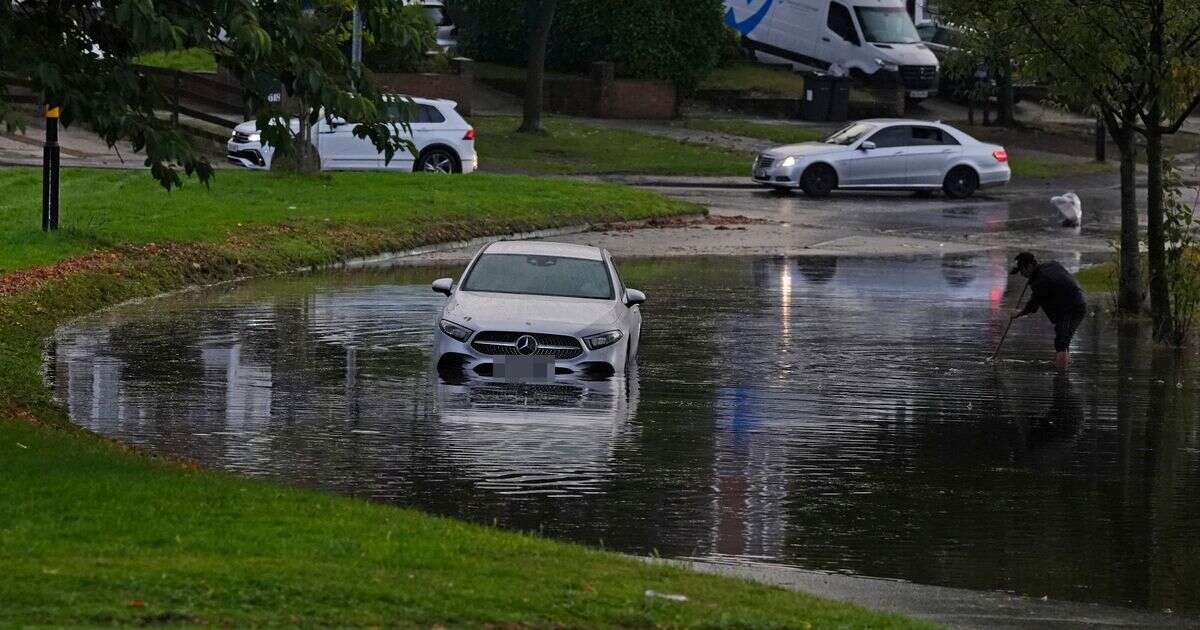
(472, 116, 754, 175)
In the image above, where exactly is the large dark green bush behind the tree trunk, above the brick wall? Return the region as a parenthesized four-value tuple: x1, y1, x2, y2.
(458, 0, 727, 90)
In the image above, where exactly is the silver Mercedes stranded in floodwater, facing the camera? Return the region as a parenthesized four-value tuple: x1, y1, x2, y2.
(433, 241, 646, 380)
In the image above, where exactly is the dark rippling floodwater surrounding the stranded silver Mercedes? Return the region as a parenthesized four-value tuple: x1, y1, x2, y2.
(48, 252, 1200, 613)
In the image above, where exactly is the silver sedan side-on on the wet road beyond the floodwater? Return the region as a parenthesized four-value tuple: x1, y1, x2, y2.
(754, 119, 1012, 199)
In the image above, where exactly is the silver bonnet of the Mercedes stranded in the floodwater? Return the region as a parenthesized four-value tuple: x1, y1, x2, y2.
(443, 290, 622, 336)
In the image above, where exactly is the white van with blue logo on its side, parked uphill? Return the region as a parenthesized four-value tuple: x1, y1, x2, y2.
(725, 0, 937, 100)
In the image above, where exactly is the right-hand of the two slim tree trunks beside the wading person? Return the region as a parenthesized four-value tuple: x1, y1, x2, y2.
(1146, 124, 1171, 341)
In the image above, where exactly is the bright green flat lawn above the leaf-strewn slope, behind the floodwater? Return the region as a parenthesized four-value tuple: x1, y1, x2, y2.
(0, 165, 695, 274)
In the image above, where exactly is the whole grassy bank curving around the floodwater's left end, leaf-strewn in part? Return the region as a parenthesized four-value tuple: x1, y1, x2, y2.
(0, 169, 920, 628)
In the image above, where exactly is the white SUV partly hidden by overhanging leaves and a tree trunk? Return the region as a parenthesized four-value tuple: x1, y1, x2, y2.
(226, 97, 479, 173)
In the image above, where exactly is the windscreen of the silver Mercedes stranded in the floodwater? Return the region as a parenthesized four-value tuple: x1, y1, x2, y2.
(462, 253, 613, 300)
